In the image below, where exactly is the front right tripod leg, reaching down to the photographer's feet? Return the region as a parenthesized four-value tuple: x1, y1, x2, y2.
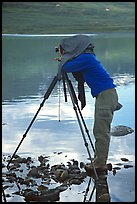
(64, 74, 98, 180)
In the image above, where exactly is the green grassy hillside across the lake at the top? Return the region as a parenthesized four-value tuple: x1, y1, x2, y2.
(2, 2, 135, 34)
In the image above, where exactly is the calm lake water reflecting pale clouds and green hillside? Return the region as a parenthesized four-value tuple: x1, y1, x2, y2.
(2, 33, 135, 202)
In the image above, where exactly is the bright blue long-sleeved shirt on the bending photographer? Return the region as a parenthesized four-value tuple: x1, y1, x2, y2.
(63, 53, 116, 97)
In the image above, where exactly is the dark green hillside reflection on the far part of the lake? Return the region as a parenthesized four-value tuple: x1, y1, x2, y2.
(2, 34, 135, 101)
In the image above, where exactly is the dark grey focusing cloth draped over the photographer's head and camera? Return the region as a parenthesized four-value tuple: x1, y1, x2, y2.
(58, 34, 94, 109)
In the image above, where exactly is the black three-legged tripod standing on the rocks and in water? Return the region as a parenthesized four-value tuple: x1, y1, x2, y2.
(7, 72, 98, 180)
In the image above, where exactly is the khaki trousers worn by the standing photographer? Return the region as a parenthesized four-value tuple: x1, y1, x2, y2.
(93, 88, 118, 166)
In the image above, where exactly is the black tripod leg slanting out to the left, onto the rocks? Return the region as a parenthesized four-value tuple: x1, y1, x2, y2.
(7, 76, 58, 168)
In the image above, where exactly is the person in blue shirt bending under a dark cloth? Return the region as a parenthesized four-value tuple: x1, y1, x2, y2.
(56, 35, 122, 171)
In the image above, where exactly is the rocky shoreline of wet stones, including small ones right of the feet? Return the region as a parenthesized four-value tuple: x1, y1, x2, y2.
(2, 152, 133, 202)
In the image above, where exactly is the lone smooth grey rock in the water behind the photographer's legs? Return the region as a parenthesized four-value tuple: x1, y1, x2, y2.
(110, 125, 134, 136)
